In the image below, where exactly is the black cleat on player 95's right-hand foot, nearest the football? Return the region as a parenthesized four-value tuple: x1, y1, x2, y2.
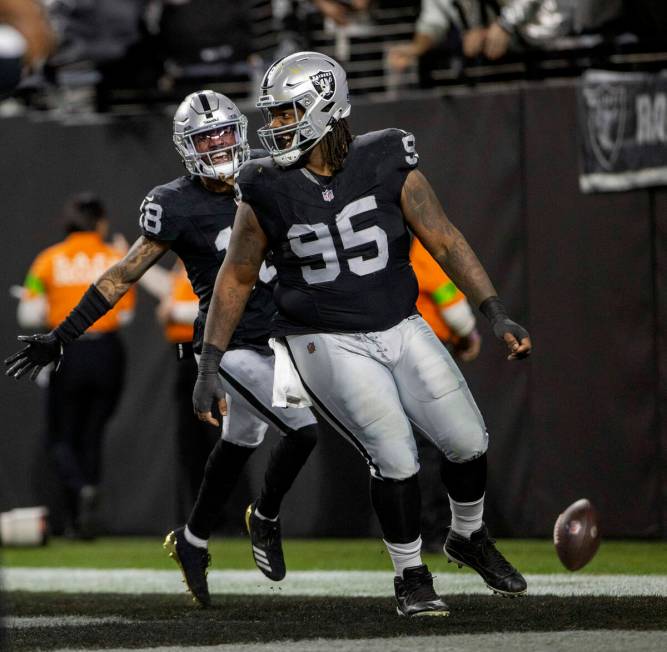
(444, 524, 527, 597)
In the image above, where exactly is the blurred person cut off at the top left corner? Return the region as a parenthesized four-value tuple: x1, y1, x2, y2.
(0, 0, 56, 98)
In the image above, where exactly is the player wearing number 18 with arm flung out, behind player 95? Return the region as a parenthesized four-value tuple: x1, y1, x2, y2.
(6, 90, 317, 606)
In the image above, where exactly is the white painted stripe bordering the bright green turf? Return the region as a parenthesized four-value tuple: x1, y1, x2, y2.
(0, 568, 667, 597)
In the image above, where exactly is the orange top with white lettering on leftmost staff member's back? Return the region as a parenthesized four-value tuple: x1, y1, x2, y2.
(24, 231, 135, 333)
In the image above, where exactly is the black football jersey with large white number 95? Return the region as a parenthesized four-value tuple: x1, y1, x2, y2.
(237, 129, 418, 335)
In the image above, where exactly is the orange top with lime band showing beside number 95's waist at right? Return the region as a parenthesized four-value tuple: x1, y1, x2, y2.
(410, 238, 465, 342)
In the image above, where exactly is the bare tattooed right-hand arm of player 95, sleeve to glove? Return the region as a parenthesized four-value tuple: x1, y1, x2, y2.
(401, 170, 497, 306)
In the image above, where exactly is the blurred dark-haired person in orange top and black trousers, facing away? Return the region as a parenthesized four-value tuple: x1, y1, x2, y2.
(17, 192, 135, 539)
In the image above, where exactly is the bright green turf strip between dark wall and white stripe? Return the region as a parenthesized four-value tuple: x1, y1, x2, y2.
(0, 537, 667, 575)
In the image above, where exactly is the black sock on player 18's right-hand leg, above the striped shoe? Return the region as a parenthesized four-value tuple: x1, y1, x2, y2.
(255, 425, 317, 518)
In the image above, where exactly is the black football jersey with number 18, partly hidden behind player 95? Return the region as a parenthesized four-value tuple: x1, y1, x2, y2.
(139, 171, 276, 352)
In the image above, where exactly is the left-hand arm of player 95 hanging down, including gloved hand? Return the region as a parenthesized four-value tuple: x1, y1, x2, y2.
(192, 202, 268, 426)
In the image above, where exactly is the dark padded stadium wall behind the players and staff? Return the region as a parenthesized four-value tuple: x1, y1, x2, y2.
(0, 82, 667, 537)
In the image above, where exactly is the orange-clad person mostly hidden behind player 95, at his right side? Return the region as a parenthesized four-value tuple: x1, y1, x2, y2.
(410, 238, 482, 553)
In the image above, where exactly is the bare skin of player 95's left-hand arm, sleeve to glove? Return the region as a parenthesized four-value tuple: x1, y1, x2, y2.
(204, 202, 268, 351)
